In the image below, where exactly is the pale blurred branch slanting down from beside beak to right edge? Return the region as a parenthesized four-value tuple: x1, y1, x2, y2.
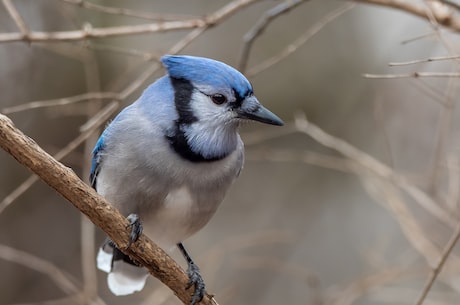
(295, 115, 458, 228)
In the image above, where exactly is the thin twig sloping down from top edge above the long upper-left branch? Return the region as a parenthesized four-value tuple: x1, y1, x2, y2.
(61, 0, 199, 21)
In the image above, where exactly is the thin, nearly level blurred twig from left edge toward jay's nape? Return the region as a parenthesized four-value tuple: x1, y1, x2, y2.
(1, 92, 121, 114)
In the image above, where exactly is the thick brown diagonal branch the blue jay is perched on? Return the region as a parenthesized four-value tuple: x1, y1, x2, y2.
(0, 114, 217, 305)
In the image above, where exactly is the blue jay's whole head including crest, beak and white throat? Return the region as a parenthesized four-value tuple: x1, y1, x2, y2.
(161, 55, 283, 160)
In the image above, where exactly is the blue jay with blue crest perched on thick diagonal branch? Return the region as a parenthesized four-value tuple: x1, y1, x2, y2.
(90, 55, 283, 305)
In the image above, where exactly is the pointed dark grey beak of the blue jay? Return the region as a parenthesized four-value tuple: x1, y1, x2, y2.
(235, 96, 284, 126)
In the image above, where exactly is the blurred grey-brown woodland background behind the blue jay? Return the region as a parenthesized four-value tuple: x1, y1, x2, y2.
(0, 0, 460, 305)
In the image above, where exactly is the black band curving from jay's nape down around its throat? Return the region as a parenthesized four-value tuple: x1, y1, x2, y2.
(166, 77, 226, 162)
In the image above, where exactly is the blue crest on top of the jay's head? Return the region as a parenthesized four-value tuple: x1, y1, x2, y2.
(161, 55, 252, 98)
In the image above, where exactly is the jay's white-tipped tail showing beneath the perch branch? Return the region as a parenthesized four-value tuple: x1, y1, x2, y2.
(97, 243, 148, 296)
